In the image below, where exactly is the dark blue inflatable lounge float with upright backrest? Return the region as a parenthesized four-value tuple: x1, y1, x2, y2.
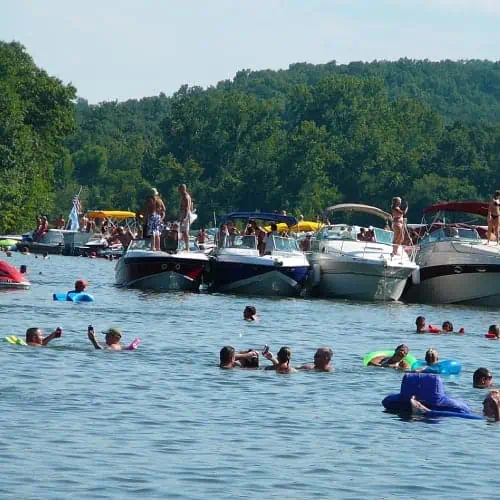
(382, 373, 474, 418)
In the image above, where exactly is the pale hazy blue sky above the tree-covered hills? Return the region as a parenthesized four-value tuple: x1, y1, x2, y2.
(0, 0, 500, 103)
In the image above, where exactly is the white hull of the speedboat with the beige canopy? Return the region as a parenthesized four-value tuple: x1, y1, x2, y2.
(310, 254, 416, 301)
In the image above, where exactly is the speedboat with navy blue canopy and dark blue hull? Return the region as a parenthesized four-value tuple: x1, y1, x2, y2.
(210, 212, 310, 296)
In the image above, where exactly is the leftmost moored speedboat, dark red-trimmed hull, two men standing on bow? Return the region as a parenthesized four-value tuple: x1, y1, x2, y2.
(115, 231, 209, 291)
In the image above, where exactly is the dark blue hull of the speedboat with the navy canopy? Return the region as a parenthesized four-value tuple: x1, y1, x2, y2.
(210, 259, 309, 297)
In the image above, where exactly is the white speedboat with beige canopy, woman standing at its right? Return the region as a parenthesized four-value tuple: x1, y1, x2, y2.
(309, 203, 418, 300)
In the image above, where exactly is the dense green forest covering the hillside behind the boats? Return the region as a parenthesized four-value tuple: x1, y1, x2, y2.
(0, 42, 500, 233)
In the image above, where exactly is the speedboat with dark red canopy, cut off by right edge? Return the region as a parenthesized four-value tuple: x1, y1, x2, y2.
(404, 202, 500, 307)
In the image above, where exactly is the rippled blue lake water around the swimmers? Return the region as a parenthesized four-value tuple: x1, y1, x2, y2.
(0, 254, 500, 499)
